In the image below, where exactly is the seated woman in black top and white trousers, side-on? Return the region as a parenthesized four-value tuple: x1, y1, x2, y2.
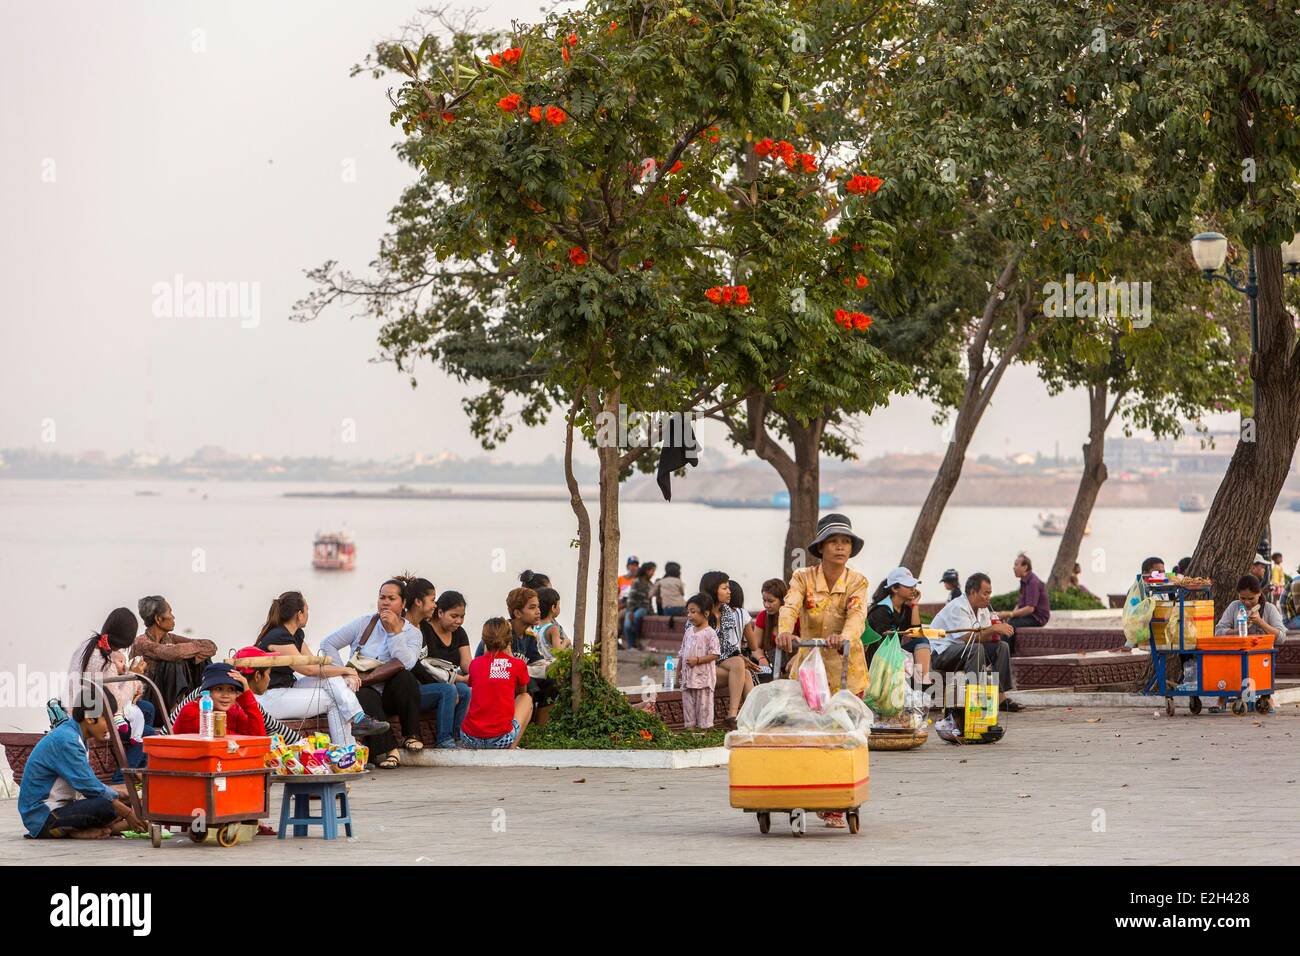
(254, 591, 389, 747)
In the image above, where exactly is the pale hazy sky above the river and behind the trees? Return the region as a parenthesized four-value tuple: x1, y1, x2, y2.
(0, 0, 1231, 460)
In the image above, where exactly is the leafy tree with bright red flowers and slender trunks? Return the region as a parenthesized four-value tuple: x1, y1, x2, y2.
(303, 0, 909, 676)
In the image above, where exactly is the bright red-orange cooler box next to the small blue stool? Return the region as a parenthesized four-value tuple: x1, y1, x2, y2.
(144, 734, 270, 822)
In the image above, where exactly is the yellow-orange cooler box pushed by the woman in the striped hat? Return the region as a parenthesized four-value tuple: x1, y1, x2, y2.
(728, 745, 871, 810)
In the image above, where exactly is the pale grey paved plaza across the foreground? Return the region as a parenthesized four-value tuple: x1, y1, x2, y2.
(0, 704, 1300, 865)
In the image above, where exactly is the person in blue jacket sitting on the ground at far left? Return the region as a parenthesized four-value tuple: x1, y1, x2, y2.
(18, 691, 144, 840)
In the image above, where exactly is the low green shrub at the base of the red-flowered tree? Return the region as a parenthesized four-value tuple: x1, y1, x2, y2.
(520, 650, 724, 750)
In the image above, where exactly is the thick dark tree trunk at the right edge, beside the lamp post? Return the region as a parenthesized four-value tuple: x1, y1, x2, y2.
(1192, 246, 1300, 613)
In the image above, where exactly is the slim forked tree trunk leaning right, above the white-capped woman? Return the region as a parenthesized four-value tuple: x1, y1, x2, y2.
(898, 258, 1032, 575)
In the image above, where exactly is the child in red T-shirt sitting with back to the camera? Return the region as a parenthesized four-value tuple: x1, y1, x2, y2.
(460, 618, 533, 750)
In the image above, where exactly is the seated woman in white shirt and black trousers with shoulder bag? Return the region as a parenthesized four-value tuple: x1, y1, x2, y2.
(321, 578, 424, 770)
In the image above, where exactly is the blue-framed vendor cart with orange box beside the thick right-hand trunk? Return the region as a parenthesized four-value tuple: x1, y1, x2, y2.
(1143, 574, 1274, 717)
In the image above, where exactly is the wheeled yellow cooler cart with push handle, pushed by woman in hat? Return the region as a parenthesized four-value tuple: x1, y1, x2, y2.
(727, 640, 870, 836)
